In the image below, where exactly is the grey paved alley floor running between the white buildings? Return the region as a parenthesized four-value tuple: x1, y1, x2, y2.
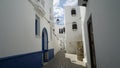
(43, 50, 85, 68)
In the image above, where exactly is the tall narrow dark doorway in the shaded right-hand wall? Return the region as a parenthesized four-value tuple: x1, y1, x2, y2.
(87, 16, 96, 68)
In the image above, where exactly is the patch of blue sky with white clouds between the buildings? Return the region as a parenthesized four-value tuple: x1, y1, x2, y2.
(53, 0, 78, 25)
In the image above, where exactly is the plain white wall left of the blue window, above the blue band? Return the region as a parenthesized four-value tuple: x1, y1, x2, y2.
(0, 0, 41, 58)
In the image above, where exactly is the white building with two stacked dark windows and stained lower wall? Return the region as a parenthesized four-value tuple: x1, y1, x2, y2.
(65, 6, 82, 54)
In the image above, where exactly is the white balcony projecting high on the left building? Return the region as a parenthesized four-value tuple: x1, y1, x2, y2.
(29, 0, 46, 16)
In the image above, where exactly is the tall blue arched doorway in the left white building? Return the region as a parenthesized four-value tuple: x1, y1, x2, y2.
(42, 28, 48, 62)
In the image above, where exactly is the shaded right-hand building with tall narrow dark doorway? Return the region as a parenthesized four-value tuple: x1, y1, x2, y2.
(79, 0, 120, 68)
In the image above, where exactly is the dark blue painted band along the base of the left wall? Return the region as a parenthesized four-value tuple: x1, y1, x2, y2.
(0, 49, 54, 68)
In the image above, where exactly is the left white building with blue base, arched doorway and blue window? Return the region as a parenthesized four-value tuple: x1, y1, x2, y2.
(0, 0, 58, 68)
